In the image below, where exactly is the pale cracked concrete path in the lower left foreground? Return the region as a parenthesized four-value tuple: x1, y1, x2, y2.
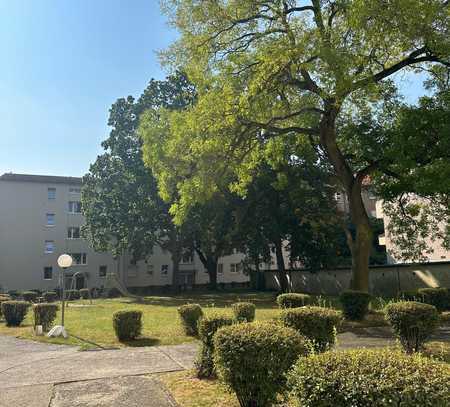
(0, 336, 196, 407)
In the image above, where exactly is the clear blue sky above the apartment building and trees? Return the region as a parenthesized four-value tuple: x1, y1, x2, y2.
(0, 0, 428, 176)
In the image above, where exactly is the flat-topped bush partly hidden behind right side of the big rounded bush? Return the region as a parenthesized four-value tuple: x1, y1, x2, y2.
(281, 307, 341, 352)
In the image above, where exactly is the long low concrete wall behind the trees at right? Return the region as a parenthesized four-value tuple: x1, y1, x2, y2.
(264, 262, 450, 296)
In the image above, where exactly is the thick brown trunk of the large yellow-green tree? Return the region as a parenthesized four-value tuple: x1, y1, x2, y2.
(320, 100, 372, 292)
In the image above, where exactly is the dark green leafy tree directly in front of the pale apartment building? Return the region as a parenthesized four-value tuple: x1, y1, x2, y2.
(82, 73, 195, 287)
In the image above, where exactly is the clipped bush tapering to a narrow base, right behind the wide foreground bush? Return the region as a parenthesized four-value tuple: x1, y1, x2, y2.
(385, 301, 440, 353)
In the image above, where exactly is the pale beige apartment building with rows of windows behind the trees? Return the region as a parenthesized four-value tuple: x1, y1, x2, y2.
(0, 173, 249, 290)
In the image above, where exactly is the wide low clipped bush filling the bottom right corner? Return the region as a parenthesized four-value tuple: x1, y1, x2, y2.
(288, 349, 450, 407)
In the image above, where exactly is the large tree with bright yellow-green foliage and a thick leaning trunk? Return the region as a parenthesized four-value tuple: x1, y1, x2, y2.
(145, 0, 450, 291)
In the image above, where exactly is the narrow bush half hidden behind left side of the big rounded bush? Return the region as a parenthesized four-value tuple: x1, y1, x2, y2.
(195, 315, 233, 378)
